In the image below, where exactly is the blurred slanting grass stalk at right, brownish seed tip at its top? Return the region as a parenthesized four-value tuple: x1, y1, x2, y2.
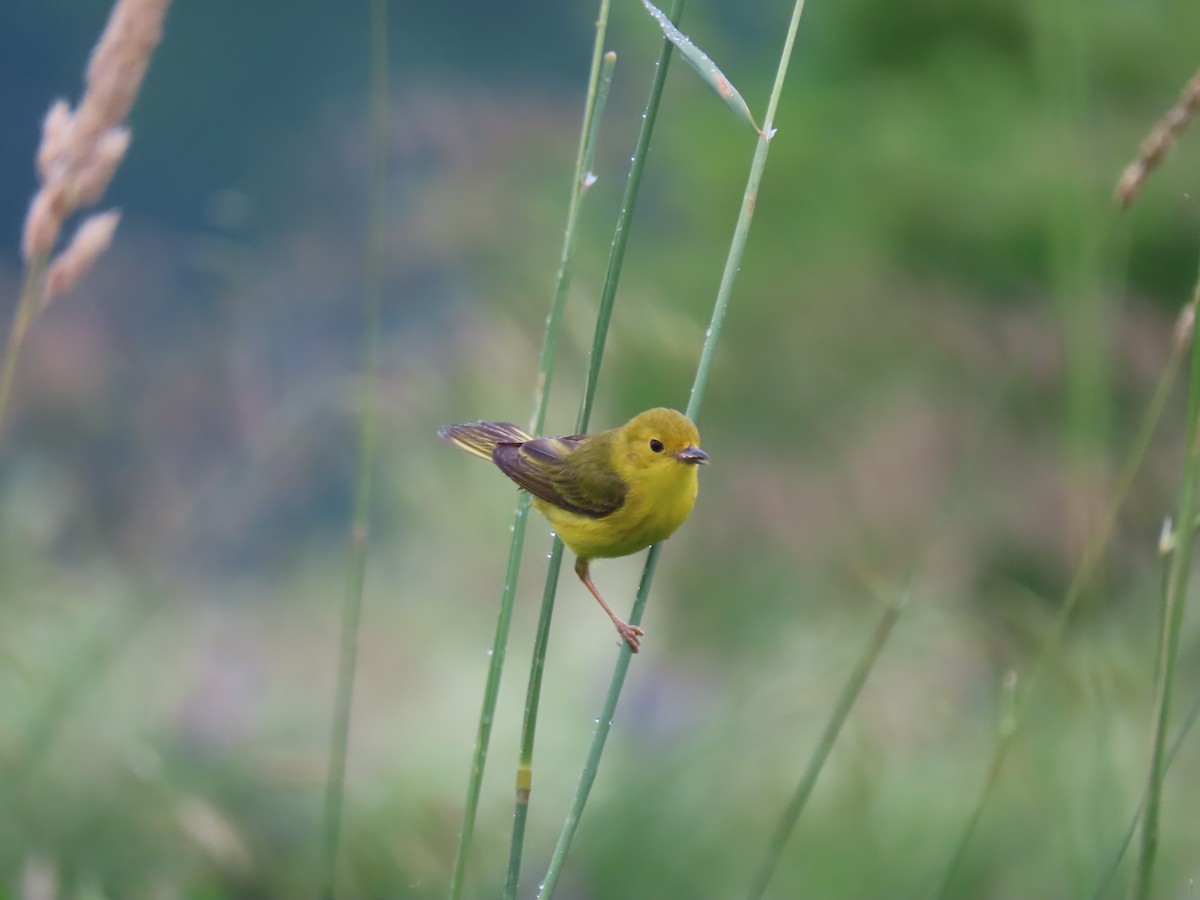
(937, 304, 1194, 898)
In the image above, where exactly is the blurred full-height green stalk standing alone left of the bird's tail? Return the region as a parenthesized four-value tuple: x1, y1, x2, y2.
(319, 0, 388, 900)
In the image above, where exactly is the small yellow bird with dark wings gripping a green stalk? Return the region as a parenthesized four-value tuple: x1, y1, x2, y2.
(438, 408, 708, 653)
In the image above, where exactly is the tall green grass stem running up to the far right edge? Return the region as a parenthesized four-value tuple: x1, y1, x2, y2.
(1135, 264, 1200, 900)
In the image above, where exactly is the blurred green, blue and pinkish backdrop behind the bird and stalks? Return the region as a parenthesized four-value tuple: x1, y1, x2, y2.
(0, 0, 1200, 899)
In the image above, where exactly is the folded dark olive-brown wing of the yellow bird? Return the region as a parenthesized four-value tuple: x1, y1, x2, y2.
(492, 434, 628, 518)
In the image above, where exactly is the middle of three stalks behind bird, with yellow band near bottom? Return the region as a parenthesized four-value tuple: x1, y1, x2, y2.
(504, 0, 684, 900)
